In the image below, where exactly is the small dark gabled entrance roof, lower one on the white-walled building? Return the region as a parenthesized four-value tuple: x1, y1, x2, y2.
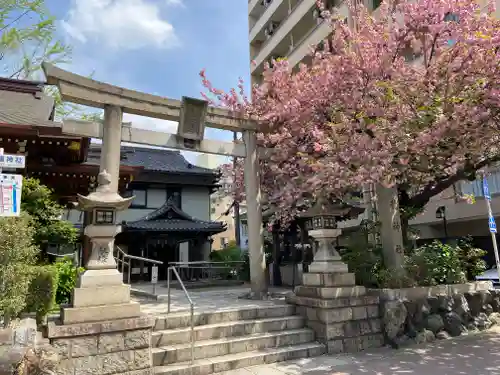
(123, 200, 226, 234)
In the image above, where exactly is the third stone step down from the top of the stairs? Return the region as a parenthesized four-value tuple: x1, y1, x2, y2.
(152, 328, 314, 366)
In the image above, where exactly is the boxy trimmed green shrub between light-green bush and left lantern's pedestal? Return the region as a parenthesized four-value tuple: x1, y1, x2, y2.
(26, 266, 58, 324)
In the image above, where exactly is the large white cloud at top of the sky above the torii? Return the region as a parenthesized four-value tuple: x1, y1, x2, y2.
(62, 0, 182, 49)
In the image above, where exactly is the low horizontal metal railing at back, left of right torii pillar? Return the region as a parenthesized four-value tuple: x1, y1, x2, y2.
(169, 261, 245, 280)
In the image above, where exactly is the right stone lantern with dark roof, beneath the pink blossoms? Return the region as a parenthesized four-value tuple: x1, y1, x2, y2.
(300, 198, 364, 272)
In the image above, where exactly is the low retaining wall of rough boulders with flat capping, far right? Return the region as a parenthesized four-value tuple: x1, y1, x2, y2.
(370, 282, 500, 348)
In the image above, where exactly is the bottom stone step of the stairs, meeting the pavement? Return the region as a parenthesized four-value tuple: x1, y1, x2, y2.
(154, 342, 326, 375)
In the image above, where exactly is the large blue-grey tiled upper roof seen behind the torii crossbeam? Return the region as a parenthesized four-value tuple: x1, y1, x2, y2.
(87, 145, 217, 176)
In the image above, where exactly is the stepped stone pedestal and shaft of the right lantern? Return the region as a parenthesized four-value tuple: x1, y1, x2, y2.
(287, 229, 384, 354)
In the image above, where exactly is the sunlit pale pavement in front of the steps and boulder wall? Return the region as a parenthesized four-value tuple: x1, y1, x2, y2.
(218, 327, 500, 375)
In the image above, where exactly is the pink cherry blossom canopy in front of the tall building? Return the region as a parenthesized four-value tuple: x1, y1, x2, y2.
(200, 0, 500, 229)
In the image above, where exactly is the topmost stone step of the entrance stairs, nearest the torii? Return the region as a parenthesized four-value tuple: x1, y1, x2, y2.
(154, 303, 295, 331)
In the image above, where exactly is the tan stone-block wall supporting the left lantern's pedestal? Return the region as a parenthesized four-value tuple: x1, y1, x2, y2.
(45, 317, 154, 375)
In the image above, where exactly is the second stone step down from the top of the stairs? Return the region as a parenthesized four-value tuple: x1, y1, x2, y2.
(152, 315, 304, 347)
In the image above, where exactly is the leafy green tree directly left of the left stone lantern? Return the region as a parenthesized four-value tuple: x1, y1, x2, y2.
(21, 178, 78, 245)
